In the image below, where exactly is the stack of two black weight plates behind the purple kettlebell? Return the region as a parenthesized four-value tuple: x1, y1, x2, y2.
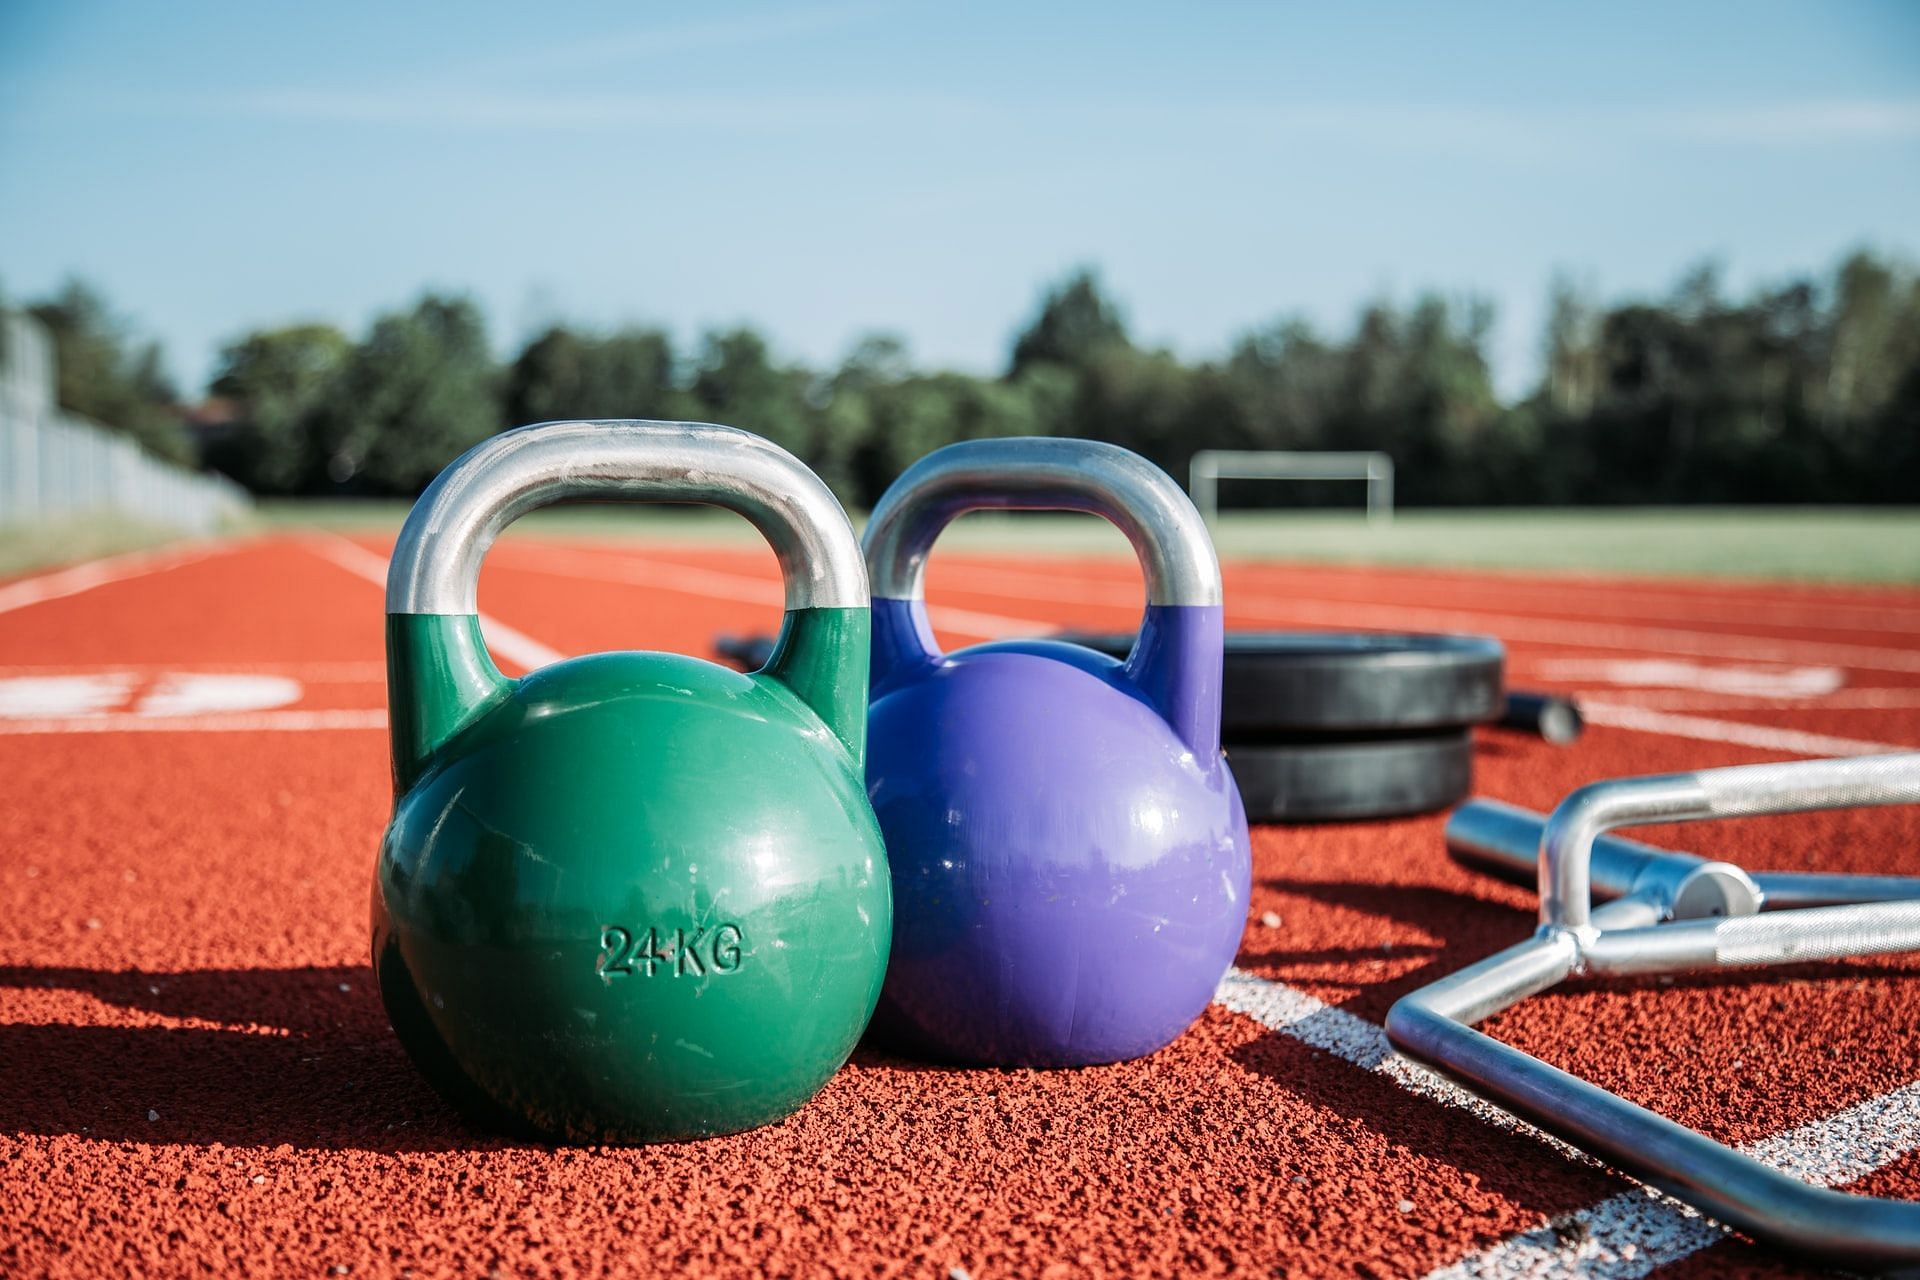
(1058, 631, 1505, 821)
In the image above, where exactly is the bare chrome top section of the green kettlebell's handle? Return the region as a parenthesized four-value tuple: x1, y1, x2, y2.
(386, 418, 868, 614)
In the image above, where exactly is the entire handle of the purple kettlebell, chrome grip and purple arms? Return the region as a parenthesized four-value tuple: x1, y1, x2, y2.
(862, 436, 1223, 764)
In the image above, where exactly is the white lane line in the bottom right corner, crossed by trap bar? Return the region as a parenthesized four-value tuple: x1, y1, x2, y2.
(1427, 1082, 1920, 1280)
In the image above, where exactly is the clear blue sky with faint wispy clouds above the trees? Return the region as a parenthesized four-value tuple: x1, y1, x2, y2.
(0, 0, 1920, 393)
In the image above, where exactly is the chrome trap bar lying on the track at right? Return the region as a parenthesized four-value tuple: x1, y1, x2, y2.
(1386, 752, 1920, 1270)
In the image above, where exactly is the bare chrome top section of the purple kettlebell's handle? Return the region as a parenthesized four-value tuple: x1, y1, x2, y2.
(860, 436, 1221, 604)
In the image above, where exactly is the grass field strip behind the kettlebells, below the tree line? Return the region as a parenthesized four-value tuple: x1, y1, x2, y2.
(261, 501, 1920, 583)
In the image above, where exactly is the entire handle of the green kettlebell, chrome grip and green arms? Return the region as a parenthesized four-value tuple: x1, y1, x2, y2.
(386, 420, 868, 791)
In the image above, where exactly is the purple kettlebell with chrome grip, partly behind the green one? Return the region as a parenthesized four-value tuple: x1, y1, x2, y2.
(864, 438, 1252, 1067)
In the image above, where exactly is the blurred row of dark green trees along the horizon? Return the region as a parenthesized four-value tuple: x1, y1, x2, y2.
(11, 251, 1920, 505)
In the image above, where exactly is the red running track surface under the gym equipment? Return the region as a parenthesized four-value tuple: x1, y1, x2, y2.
(0, 535, 1920, 1278)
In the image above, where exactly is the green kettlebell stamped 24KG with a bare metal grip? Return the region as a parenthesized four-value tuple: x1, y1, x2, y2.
(372, 422, 893, 1142)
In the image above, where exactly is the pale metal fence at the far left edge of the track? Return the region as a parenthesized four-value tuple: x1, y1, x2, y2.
(0, 313, 252, 533)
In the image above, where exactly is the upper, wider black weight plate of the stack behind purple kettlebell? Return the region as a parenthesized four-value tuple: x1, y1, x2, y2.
(1054, 631, 1507, 739)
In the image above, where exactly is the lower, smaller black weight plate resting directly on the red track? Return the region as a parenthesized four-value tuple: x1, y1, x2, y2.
(1227, 729, 1473, 821)
